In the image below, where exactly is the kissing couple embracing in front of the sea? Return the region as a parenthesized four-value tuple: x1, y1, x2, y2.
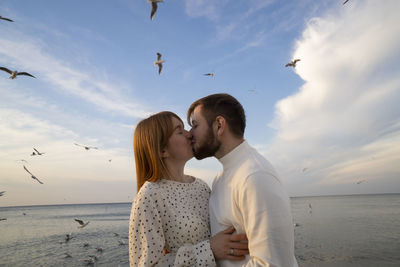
(129, 94, 297, 267)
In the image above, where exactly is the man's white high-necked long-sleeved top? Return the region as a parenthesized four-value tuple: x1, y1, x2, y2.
(210, 141, 298, 267)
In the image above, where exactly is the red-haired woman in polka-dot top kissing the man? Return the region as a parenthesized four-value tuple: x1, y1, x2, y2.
(129, 111, 248, 266)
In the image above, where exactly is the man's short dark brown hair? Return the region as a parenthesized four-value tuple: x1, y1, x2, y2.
(187, 94, 246, 138)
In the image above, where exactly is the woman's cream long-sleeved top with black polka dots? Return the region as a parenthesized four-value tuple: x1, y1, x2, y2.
(129, 179, 216, 266)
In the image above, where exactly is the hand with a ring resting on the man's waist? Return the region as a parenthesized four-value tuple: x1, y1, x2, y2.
(210, 226, 249, 261)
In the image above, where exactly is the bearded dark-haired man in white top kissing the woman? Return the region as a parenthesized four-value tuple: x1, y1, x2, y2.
(187, 94, 297, 267)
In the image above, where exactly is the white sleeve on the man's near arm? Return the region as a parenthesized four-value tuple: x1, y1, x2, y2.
(237, 172, 297, 267)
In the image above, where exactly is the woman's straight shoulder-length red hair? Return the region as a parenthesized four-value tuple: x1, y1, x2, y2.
(133, 111, 182, 192)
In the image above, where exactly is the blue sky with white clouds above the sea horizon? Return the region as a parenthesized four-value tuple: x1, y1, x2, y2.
(0, 0, 400, 206)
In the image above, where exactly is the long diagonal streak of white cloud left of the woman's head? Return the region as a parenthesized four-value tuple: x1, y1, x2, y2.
(0, 30, 151, 118)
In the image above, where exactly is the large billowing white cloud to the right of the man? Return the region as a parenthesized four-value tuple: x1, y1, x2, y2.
(265, 0, 400, 197)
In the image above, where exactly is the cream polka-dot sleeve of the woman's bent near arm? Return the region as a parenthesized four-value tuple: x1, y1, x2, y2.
(129, 188, 216, 267)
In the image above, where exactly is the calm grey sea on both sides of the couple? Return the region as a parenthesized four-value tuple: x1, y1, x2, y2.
(0, 194, 400, 267)
